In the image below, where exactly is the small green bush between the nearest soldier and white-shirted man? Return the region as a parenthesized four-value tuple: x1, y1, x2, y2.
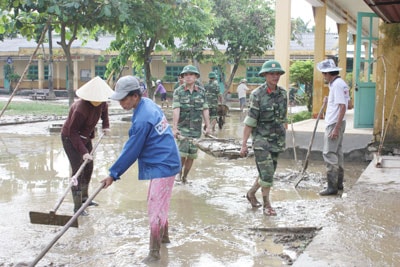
(290, 60, 314, 112)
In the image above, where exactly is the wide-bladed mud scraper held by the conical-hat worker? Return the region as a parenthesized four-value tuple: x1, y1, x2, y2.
(29, 133, 104, 227)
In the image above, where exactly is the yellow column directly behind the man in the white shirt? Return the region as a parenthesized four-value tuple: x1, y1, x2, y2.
(312, 4, 329, 118)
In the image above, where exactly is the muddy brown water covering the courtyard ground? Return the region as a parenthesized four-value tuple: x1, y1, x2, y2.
(0, 113, 372, 267)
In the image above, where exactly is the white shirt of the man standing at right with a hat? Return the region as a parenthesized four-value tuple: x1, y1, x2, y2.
(325, 77, 350, 126)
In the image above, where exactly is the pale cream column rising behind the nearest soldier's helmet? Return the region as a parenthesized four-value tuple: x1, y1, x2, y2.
(274, 0, 292, 92)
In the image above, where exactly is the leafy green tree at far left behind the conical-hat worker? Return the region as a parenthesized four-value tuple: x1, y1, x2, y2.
(0, 0, 130, 105)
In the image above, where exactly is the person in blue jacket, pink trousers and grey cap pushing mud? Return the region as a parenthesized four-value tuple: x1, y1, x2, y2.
(102, 76, 181, 263)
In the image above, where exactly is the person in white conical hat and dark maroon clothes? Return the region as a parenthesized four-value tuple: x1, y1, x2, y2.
(61, 77, 113, 216)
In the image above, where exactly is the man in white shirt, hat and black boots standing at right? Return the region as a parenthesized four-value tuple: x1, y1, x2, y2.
(317, 59, 350, 196)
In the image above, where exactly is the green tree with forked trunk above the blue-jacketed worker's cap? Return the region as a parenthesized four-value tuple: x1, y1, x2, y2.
(107, 0, 216, 97)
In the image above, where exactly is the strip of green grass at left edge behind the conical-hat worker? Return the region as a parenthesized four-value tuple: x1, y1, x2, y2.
(0, 102, 69, 116)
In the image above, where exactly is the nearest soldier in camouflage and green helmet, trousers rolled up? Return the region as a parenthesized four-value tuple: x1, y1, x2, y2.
(240, 60, 287, 216)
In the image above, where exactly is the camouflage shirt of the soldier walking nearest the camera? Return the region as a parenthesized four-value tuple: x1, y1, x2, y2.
(244, 83, 287, 152)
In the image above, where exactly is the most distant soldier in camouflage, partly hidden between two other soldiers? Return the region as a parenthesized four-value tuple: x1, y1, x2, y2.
(204, 72, 220, 132)
